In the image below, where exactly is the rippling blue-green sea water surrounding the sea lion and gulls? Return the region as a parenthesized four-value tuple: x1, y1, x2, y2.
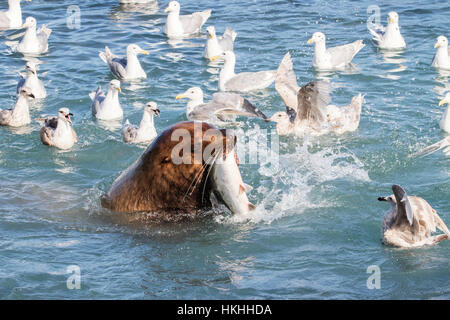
(0, 0, 450, 299)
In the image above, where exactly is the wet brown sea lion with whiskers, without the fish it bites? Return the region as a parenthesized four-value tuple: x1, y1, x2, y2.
(101, 121, 236, 214)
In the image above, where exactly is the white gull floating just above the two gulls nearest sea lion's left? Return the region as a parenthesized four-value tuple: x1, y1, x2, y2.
(89, 80, 123, 120)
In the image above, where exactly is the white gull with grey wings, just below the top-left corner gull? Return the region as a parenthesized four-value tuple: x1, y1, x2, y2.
(5, 17, 52, 54)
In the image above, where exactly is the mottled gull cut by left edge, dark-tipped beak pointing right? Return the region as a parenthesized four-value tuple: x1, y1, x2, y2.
(0, 87, 34, 127)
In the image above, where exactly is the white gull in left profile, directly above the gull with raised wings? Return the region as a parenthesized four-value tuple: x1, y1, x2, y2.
(308, 32, 365, 70)
